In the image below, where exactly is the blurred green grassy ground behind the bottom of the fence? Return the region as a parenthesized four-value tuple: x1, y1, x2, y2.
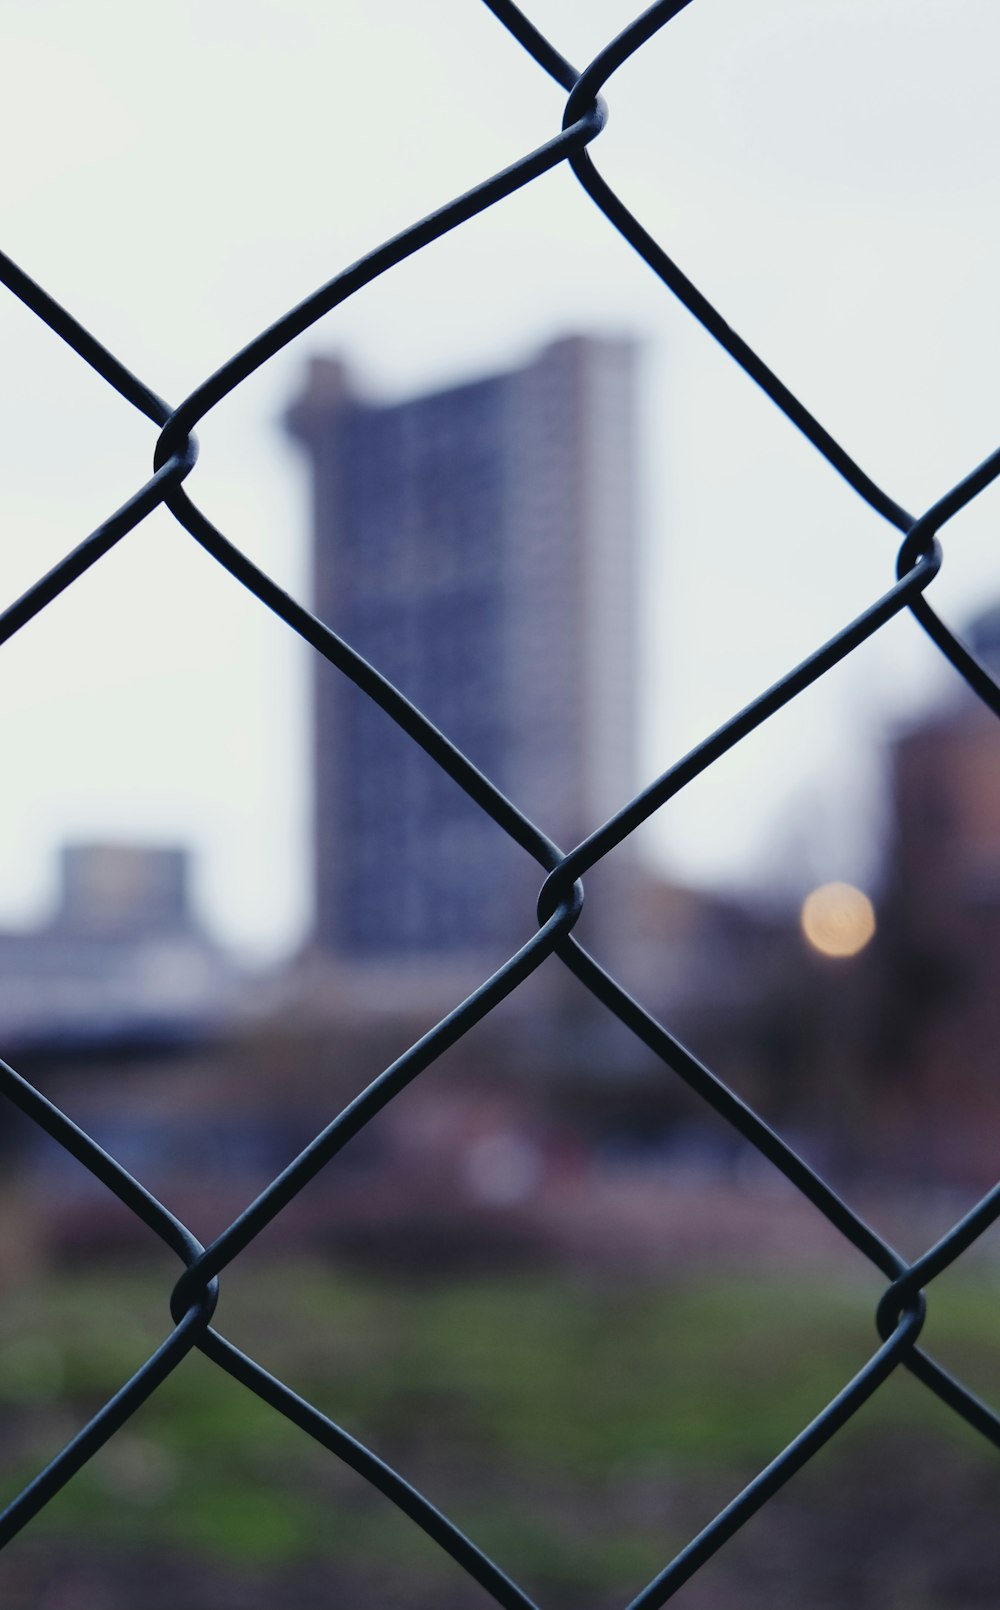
(0, 1264, 1000, 1610)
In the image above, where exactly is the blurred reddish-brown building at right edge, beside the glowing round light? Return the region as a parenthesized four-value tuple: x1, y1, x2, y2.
(876, 607, 1000, 1183)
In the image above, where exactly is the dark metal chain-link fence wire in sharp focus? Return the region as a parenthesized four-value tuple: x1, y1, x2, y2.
(0, 0, 1000, 1610)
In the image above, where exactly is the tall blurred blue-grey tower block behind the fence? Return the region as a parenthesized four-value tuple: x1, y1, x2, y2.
(288, 336, 636, 964)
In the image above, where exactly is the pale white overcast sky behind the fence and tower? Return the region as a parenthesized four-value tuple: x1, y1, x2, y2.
(0, 0, 1000, 953)
